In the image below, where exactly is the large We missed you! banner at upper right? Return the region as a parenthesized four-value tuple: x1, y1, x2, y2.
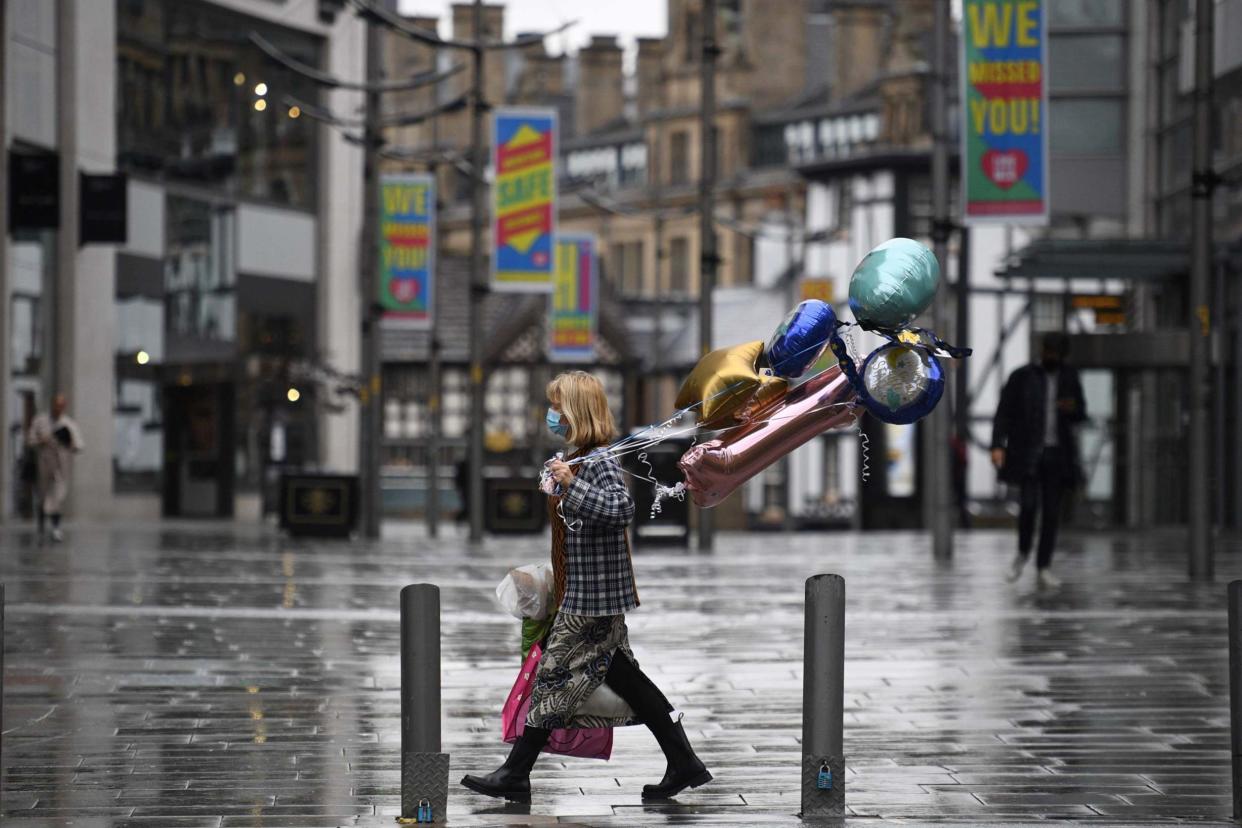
(961, 0, 1048, 225)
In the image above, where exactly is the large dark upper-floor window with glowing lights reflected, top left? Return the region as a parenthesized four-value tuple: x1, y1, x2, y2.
(117, 0, 320, 210)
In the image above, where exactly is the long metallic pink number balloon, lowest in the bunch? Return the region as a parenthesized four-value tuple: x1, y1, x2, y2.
(678, 366, 861, 509)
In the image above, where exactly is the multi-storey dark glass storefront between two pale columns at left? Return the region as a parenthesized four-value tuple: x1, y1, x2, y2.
(106, 0, 323, 515)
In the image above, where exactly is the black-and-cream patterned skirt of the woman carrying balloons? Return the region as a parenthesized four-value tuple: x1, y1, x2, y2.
(527, 612, 640, 730)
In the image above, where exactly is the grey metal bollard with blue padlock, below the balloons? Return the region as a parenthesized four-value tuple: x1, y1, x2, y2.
(800, 575, 846, 817)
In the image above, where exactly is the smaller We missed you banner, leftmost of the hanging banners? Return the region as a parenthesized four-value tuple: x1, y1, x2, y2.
(379, 173, 436, 328)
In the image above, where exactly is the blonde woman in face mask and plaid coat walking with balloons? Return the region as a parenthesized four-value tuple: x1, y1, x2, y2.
(462, 371, 712, 802)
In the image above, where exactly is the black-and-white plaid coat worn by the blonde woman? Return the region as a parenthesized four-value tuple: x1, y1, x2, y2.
(560, 457, 638, 616)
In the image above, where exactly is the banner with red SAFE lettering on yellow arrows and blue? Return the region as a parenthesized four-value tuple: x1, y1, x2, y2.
(492, 108, 556, 293)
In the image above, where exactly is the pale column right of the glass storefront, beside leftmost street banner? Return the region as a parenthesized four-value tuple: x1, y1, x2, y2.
(317, 14, 364, 473)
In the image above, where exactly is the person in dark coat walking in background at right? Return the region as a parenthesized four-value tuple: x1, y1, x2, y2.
(992, 333, 1087, 588)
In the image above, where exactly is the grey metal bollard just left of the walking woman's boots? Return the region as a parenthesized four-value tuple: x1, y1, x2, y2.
(401, 583, 448, 823)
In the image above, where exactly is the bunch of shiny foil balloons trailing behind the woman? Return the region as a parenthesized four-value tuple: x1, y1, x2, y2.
(677, 238, 970, 508)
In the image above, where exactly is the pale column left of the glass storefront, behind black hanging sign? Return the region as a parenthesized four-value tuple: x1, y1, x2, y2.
(55, 0, 117, 518)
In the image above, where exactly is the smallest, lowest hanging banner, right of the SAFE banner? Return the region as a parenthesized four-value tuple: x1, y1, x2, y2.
(548, 233, 600, 362)
